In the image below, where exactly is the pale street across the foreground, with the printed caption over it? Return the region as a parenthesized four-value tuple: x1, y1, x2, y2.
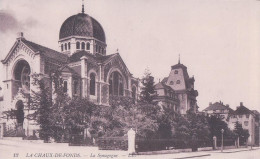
(0, 140, 260, 159)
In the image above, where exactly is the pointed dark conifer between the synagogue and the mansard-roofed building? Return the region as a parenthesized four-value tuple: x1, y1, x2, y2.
(140, 69, 156, 104)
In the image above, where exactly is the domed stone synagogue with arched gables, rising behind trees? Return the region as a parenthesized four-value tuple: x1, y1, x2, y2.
(0, 6, 139, 135)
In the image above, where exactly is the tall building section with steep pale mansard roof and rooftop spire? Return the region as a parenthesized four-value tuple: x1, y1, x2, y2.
(162, 60, 198, 115)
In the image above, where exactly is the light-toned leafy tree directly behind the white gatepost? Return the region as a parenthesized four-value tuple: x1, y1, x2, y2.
(104, 96, 158, 138)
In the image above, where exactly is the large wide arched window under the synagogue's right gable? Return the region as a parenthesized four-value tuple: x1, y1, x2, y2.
(109, 72, 124, 96)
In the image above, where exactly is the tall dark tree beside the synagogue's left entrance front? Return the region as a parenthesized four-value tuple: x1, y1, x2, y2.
(28, 69, 70, 141)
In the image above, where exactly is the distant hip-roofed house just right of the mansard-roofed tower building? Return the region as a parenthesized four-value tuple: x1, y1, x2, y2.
(203, 101, 234, 122)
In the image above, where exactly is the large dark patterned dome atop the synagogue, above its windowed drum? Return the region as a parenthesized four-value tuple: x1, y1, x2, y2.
(59, 13, 106, 43)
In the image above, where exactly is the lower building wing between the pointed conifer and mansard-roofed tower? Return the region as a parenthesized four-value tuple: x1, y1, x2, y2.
(154, 82, 180, 113)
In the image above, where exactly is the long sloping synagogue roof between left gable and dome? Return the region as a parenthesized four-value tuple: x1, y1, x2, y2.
(21, 38, 68, 62)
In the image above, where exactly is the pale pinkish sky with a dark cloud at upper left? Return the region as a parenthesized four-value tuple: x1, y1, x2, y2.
(0, 0, 260, 111)
